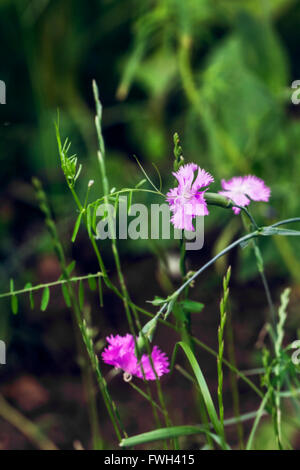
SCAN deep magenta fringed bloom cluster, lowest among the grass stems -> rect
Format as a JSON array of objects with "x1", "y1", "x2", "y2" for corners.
[{"x1": 102, "y1": 334, "x2": 170, "y2": 380}]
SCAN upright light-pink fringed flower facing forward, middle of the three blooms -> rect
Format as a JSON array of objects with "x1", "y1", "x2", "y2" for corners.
[{"x1": 167, "y1": 163, "x2": 214, "y2": 231}]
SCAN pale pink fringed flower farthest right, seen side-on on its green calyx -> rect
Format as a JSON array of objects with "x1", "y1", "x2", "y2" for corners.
[{"x1": 219, "y1": 175, "x2": 271, "y2": 214}]
